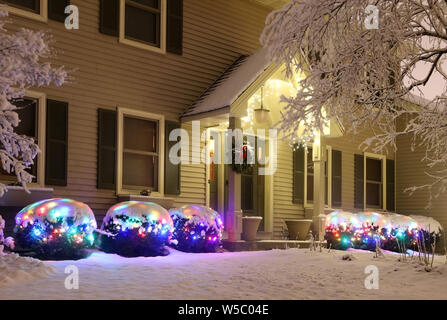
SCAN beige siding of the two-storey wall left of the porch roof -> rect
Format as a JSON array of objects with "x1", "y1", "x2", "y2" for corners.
[{"x1": 10, "y1": 0, "x2": 269, "y2": 213}]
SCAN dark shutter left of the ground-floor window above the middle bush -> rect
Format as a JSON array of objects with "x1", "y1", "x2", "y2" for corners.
[{"x1": 97, "y1": 109, "x2": 116, "y2": 190}]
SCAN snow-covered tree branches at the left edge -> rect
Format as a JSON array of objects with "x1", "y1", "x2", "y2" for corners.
[{"x1": 0, "y1": 8, "x2": 67, "y2": 196}]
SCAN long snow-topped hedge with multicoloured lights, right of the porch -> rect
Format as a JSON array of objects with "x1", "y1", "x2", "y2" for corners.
[{"x1": 325, "y1": 211, "x2": 443, "y2": 252}]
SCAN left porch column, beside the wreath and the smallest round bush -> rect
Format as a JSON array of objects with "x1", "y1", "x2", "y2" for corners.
[{"x1": 229, "y1": 116, "x2": 242, "y2": 241}]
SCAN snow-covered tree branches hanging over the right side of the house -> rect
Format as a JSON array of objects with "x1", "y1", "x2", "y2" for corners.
[{"x1": 261, "y1": 0, "x2": 447, "y2": 205}]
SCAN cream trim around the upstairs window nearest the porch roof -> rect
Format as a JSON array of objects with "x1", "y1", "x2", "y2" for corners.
[{"x1": 118, "y1": 0, "x2": 167, "y2": 54}]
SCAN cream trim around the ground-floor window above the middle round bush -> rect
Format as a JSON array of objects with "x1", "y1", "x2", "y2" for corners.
[{"x1": 116, "y1": 107, "x2": 165, "y2": 197}]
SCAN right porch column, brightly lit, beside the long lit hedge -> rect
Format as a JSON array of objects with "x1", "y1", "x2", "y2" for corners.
[{"x1": 312, "y1": 135, "x2": 326, "y2": 240}]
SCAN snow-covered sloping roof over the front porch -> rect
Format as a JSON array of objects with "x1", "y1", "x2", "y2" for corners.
[{"x1": 181, "y1": 49, "x2": 271, "y2": 118}]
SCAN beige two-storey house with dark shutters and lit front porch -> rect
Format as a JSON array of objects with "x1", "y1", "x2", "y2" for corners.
[{"x1": 0, "y1": 0, "x2": 447, "y2": 240}]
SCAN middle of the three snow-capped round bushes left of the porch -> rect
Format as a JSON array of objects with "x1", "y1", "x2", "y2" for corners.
[{"x1": 100, "y1": 201, "x2": 173, "y2": 257}]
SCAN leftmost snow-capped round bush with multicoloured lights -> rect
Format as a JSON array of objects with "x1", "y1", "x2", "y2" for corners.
[{"x1": 14, "y1": 198, "x2": 97, "y2": 260}]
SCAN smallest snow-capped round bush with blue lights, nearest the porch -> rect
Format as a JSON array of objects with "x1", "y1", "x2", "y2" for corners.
[{"x1": 169, "y1": 205, "x2": 223, "y2": 252}]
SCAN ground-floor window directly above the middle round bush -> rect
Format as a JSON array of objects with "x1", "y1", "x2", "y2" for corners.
[{"x1": 118, "y1": 109, "x2": 164, "y2": 195}]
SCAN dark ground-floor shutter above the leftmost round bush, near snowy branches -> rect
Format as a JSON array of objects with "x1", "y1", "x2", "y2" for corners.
[{"x1": 45, "y1": 100, "x2": 68, "y2": 186}]
